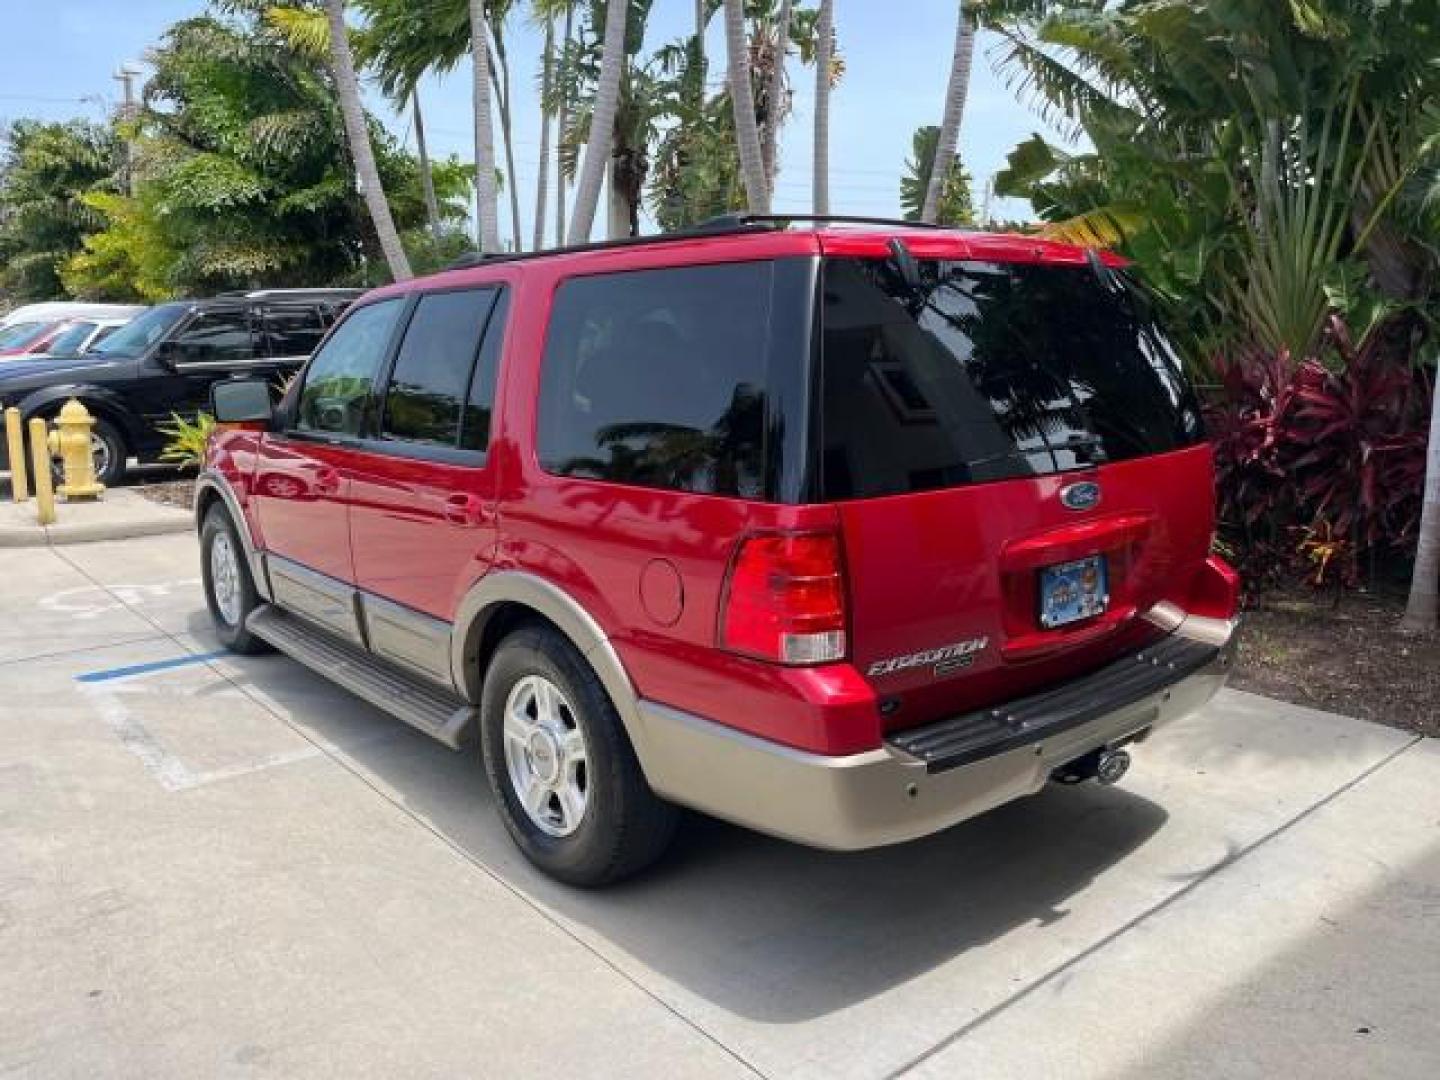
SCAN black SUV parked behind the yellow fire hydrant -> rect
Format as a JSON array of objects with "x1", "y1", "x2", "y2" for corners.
[{"x1": 0, "y1": 289, "x2": 361, "y2": 484}]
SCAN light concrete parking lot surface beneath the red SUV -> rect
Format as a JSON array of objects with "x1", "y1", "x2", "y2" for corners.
[{"x1": 0, "y1": 536, "x2": 1440, "y2": 1080}]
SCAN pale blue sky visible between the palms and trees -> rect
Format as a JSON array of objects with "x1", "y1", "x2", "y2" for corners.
[{"x1": 0, "y1": 0, "x2": 1071, "y2": 246}]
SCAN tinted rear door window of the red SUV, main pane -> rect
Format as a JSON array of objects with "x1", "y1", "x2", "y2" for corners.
[{"x1": 382, "y1": 288, "x2": 495, "y2": 449}]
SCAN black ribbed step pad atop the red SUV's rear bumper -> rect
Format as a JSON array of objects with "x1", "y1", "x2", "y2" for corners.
[{"x1": 886, "y1": 635, "x2": 1224, "y2": 773}]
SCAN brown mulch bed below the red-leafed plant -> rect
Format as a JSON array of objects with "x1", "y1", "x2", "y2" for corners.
[{"x1": 1230, "y1": 590, "x2": 1440, "y2": 736}]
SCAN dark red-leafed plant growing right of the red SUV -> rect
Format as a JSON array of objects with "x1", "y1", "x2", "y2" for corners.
[{"x1": 1210, "y1": 317, "x2": 1430, "y2": 586}]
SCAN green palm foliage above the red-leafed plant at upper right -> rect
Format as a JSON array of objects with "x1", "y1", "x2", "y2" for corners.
[{"x1": 981, "y1": 0, "x2": 1440, "y2": 360}]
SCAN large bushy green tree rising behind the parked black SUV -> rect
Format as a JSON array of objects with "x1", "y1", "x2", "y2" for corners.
[{"x1": 65, "y1": 0, "x2": 474, "y2": 300}]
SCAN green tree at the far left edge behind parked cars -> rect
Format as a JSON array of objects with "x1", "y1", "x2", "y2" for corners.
[{"x1": 0, "y1": 120, "x2": 120, "y2": 301}]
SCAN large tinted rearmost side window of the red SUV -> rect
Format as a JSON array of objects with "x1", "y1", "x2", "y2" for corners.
[{"x1": 537, "y1": 262, "x2": 775, "y2": 498}]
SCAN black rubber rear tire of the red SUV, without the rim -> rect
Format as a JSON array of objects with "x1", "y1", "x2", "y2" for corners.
[{"x1": 481, "y1": 624, "x2": 680, "y2": 887}]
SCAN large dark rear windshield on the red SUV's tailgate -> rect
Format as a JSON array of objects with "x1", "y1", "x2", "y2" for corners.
[{"x1": 821, "y1": 258, "x2": 1204, "y2": 500}]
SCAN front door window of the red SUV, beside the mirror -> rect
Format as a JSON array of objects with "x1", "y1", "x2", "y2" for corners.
[{"x1": 295, "y1": 297, "x2": 406, "y2": 435}]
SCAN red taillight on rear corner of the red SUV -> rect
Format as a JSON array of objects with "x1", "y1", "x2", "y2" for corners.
[{"x1": 720, "y1": 533, "x2": 845, "y2": 664}]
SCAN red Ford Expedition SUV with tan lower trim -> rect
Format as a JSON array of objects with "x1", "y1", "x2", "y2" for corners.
[{"x1": 196, "y1": 217, "x2": 1238, "y2": 884}]
